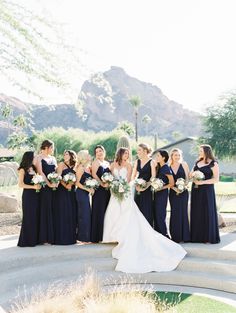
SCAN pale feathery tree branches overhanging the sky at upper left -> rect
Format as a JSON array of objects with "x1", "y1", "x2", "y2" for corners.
[{"x1": 0, "y1": 0, "x2": 84, "y2": 100}]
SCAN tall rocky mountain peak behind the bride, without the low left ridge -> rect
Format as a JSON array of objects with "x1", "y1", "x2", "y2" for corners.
[{"x1": 80, "y1": 66, "x2": 200, "y2": 138}]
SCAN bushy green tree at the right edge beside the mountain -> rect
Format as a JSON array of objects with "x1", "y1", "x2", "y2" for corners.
[{"x1": 200, "y1": 94, "x2": 236, "y2": 158}]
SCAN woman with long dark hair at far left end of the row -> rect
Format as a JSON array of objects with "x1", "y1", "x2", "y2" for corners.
[{"x1": 18, "y1": 151, "x2": 41, "y2": 247}]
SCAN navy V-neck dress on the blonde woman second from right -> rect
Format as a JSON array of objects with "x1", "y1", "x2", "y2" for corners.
[{"x1": 169, "y1": 164, "x2": 190, "y2": 242}]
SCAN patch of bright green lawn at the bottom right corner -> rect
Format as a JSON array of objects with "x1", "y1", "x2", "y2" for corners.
[{"x1": 155, "y1": 291, "x2": 236, "y2": 313}]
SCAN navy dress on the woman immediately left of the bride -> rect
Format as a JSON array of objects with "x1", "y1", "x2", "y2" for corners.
[{"x1": 91, "y1": 165, "x2": 111, "y2": 242}]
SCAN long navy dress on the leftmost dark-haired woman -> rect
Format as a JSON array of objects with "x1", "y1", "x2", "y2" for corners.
[{"x1": 18, "y1": 172, "x2": 39, "y2": 247}]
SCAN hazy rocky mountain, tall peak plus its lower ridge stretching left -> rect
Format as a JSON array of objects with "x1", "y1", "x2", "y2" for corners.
[{"x1": 0, "y1": 66, "x2": 203, "y2": 143}]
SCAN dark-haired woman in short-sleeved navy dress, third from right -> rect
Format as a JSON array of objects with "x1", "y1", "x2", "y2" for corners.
[{"x1": 154, "y1": 150, "x2": 174, "y2": 237}]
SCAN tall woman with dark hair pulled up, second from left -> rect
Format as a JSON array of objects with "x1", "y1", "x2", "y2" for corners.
[{"x1": 36, "y1": 140, "x2": 57, "y2": 244}]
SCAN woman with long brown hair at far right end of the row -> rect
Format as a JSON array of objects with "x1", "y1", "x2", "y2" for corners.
[{"x1": 190, "y1": 145, "x2": 220, "y2": 243}]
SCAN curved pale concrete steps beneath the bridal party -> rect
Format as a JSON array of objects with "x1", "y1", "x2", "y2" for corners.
[{"x1": 0, "y1": 233, "x2": 236, "y2": 313}]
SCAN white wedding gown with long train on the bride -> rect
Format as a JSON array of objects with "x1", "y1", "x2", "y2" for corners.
[{"x1": 103, "y1": 168, "x2": 186, "y2": 273}]
